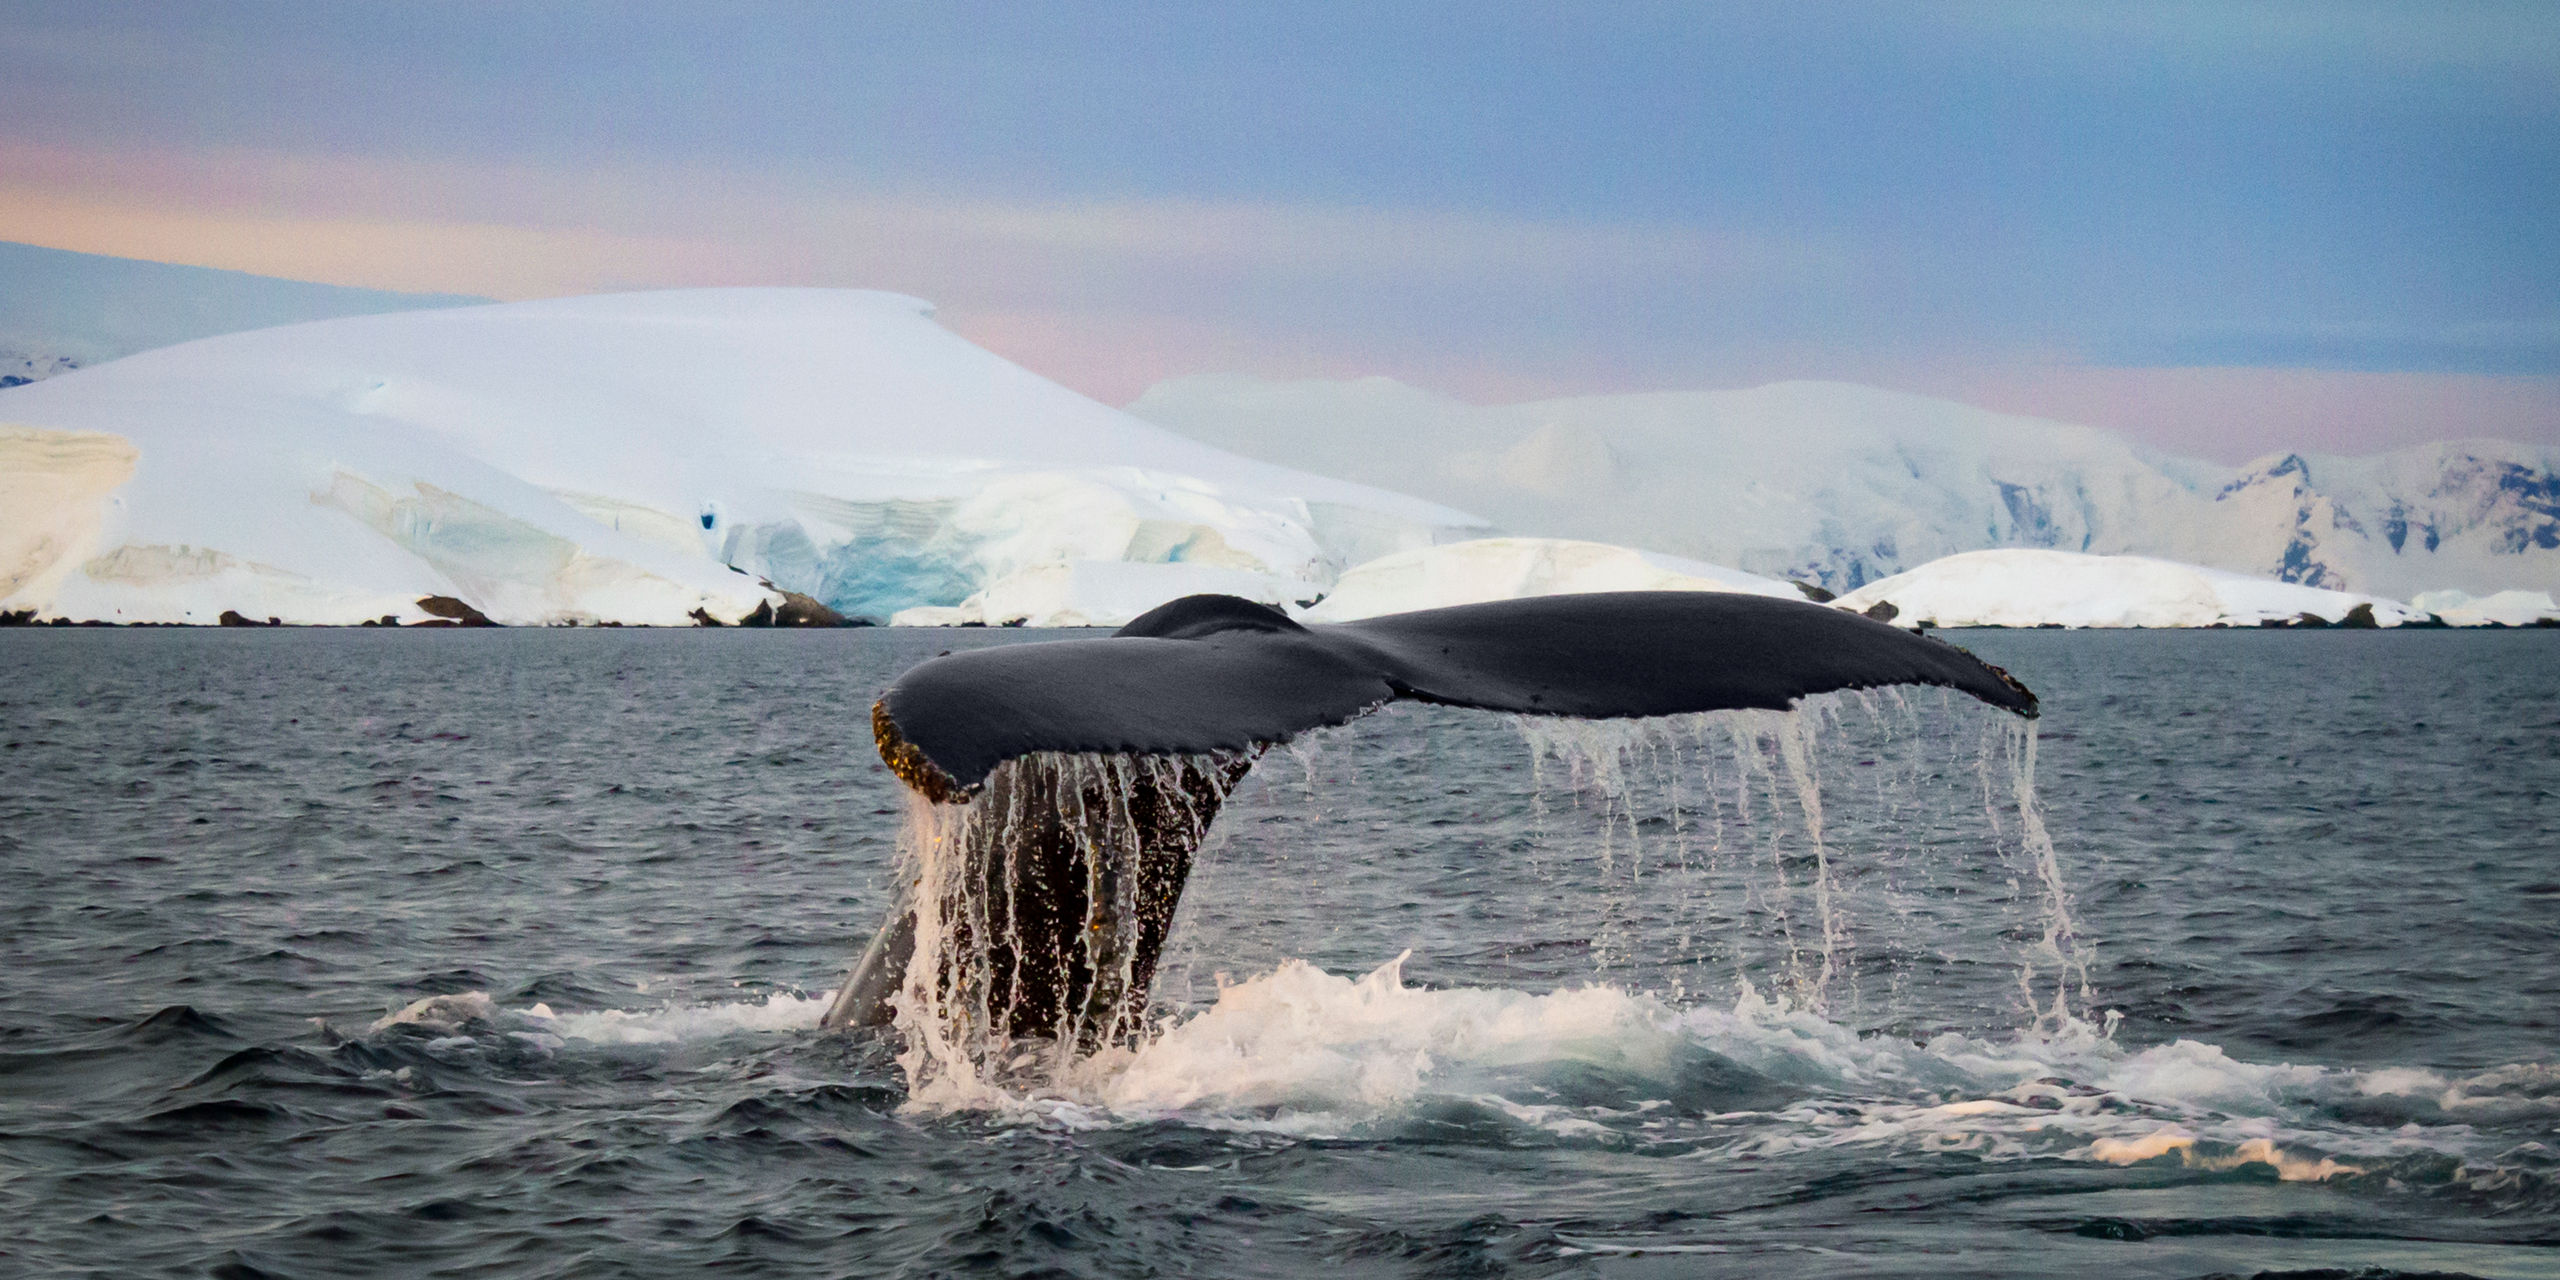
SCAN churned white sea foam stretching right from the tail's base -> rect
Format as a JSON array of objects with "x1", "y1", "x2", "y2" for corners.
[{"x1": 880, "y1": 955, "x2": 2560, "y2": 1180}]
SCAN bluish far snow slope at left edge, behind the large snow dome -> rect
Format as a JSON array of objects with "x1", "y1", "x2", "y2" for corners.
[{"x1": 0, "y1": 241, "x2": 486, "y2": 387}]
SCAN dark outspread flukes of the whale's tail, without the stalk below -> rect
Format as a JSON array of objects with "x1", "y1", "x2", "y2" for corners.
[{"x1": 870, "y1": 591, "x2": 2035, "y2": 804}]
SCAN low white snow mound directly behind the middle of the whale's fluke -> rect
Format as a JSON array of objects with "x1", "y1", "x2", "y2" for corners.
[{"x1": 1306, "y1": 538, "x2": 1805, "y2": 622}]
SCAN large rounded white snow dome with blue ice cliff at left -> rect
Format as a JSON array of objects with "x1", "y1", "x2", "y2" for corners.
[{"x1": 0, "y1": 289, "x2": 1482, "y2": 625}]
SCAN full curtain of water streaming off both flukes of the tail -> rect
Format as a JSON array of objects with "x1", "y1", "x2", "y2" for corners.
[{"x1": 899, "y1": 691, "x2": 2089, "y2": 1106}]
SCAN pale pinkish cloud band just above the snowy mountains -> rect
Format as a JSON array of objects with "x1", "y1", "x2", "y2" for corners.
[{"x1": 0, "y1": 141, "x2": 2560, "y2": 461}]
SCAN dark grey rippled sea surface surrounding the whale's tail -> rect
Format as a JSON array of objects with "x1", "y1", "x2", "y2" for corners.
[{"x1": 0, "y1": 630, "x2": 2560, "y2": 1277}]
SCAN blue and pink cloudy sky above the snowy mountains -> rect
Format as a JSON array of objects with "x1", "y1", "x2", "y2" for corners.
[{"x1": 0, "y1": 0, "x2": 2560, "y2": 461}]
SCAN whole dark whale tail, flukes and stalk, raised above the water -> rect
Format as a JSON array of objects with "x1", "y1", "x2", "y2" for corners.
[{"x1": 827, "y1": 591, "x2": 2035, "y2": 1047}]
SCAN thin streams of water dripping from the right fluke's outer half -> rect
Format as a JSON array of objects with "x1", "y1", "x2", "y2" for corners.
[{"x1": 1516, "y1": 689, "x2": 2092, "y2": 1037}]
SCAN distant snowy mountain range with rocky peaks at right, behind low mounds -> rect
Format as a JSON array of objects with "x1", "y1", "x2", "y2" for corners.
[{"x1": 1129, "y1": 376, "x2": 2560, "y2": 599}]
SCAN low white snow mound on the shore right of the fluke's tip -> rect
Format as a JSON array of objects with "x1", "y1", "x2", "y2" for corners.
[{"x1": 1838, "y1": 548, "x2": 2424, "y2": 627}]
